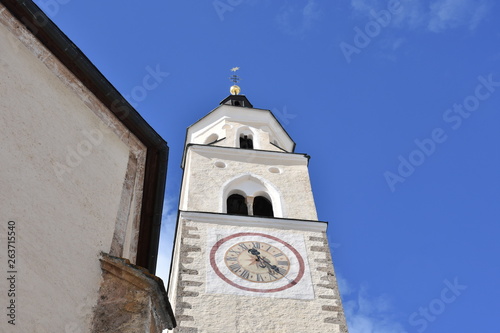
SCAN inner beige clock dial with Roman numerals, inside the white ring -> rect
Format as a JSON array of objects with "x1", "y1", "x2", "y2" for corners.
[{"x1": 224, "y1": 241, "x2": 290, "y2": 283}]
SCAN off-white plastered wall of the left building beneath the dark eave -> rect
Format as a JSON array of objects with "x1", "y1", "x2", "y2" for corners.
[{"x1": 0, "y1": 5, "x2": 158, "y2": 333}]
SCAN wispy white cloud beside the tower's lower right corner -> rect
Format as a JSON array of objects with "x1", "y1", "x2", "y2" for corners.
[{"x1": 337, "y1": 276, "x2": 406, "y2": 333}]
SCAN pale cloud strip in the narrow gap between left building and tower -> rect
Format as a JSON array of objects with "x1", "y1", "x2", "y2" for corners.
[{"x1": 156, "y1": 197, "x2": 181, "y2": 286}]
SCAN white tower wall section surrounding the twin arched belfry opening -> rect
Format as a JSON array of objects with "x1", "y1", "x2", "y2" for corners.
[{"x1": 179, "y1": 146, "x2": 317, "y2": 220}]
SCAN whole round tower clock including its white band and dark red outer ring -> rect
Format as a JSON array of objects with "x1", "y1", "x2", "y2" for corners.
[{"x1": 210, "y1": 232, "x2": 305, "y2": 293}]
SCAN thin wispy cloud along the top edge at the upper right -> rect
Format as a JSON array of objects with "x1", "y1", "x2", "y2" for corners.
[{"x1": 351, "y1": 0, "x2": 493, "y2": 32}]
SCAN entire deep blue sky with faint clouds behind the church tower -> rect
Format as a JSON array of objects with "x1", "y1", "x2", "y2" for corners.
[{"x1": 36, "y1": 0, "x2": 500, "y2": 333}]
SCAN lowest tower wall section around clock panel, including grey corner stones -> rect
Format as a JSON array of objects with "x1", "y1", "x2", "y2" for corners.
[{"x1": 170, "y1": 215, "x2": 347, "y2": 333}]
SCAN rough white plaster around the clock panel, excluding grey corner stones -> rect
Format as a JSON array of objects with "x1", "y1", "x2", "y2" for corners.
[{"x1": 169, "y1": 212, "x2": 342, "y2": 333}]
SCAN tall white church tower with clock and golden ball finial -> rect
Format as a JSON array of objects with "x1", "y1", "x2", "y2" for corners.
[{"x1": 168, "y1": 68, "x2": 347, "y2": 333}]
